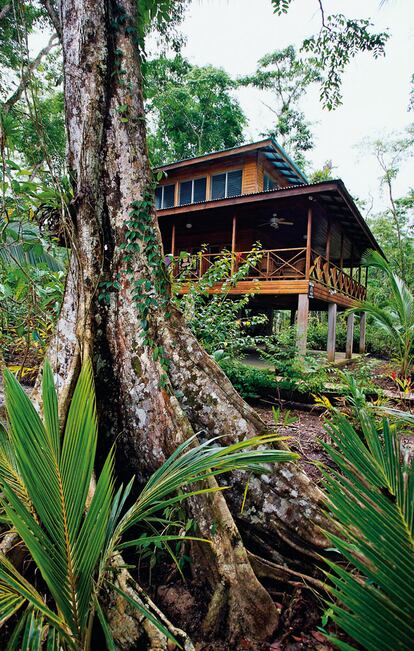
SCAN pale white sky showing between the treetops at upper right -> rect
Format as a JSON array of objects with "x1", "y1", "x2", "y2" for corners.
[{"x1": 181, "y1": 0, "x2": 414, "y2": 211}]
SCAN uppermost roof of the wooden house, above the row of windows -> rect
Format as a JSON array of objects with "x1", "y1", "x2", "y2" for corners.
[{"x1": 155, "y1": 138, "x2": 308, "y2": 185}]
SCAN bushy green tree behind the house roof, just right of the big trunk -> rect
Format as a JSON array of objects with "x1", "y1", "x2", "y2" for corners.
[{"x1": 144, "y1": 55, "x2": 246, "y2": 165}]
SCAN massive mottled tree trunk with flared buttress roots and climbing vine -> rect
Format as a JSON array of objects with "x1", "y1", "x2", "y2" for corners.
[{"x1": 44, "y1": 0, "x2": 325, "y2": 649}]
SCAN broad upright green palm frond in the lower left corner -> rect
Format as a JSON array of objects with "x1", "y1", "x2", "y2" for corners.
[{"x1": 1, "y1": 363, "x2": 113, "y2": 640}]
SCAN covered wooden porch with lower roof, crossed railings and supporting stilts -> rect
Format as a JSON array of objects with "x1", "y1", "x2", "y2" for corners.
[{"x1": 158, "y1": 181, "x2": 378, "y2": 361}]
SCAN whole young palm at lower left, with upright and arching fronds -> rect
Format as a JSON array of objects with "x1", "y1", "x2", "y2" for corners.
[{"x1": 0, "y1": 362, "x2": 297, "y2": 650}]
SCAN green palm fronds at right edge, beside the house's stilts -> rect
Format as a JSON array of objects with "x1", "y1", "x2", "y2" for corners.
[{"x1": 350, "y1": 251, "x2": 414, "y2": 378}]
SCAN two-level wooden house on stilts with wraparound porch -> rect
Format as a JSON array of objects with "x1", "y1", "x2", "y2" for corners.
[{"x1": 156, "y1": 139, "x2": 380, "y2": 361}]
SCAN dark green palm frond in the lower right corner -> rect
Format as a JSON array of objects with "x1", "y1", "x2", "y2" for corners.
[{"x1": 323, "y1": 384, "x2": 414, "y2": 651}]
